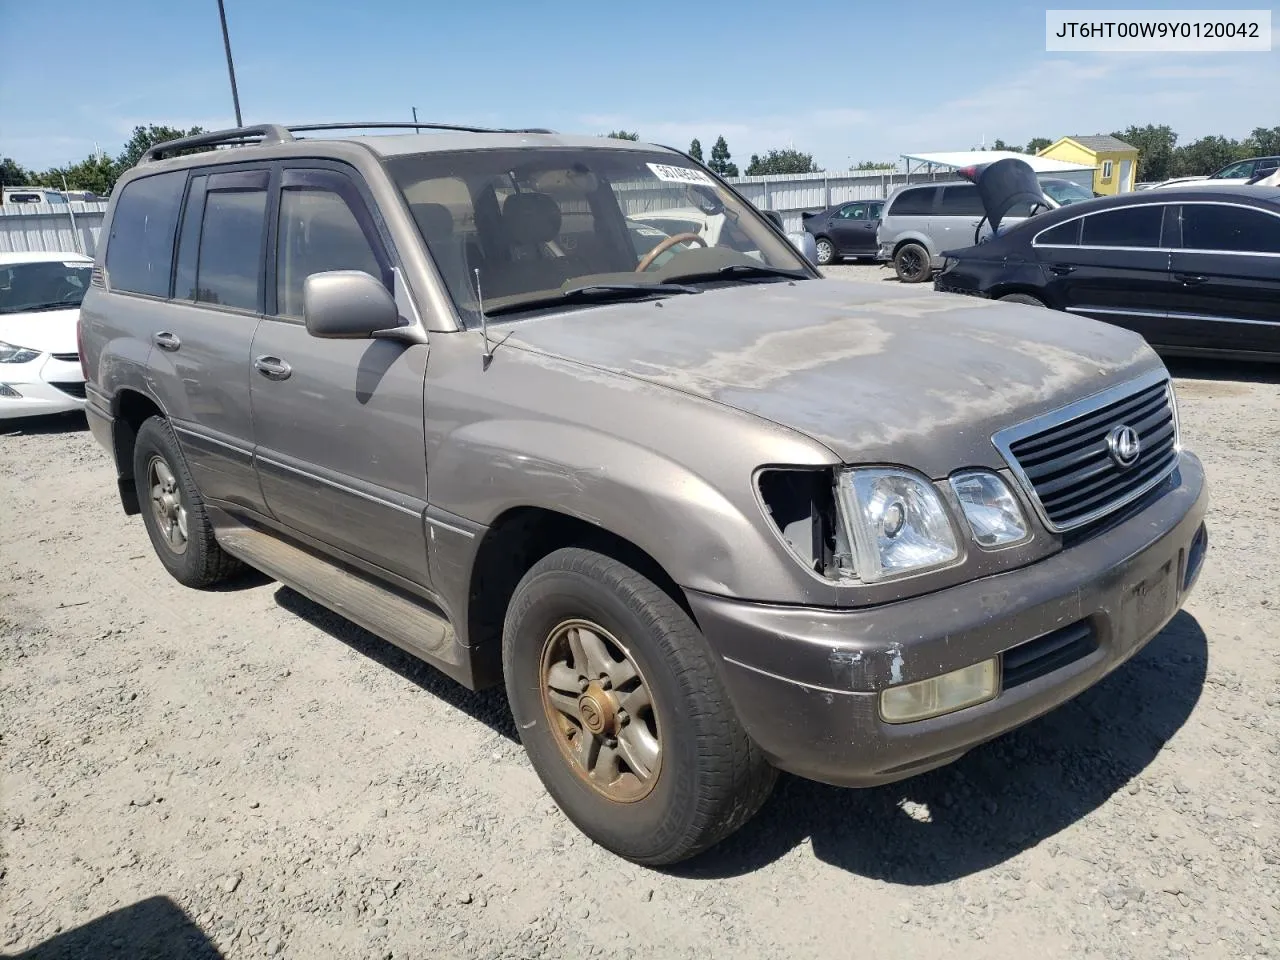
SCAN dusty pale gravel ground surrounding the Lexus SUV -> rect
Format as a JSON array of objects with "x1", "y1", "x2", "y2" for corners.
[{"x1": 0, "y1": 280, "x2": 1280, "y2": 960}]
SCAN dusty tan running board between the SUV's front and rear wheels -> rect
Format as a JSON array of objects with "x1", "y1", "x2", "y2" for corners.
[{"x1": 210, "y1": 511, "x2": 474, "y2": 686}]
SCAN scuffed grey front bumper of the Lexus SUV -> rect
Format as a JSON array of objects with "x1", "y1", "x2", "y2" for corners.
[{"x1": 687, "y1": 453, "x2": 1208, "y2": 786}]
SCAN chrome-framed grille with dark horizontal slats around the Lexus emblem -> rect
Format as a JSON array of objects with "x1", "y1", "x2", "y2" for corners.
[{"x1": 992, "y1": 370, "x2": 1179, "y2": 532}]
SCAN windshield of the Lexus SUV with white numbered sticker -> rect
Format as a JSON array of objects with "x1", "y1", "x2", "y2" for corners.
[{"x1": 387, "y1": 148, "x2": 812, "y2": 320}]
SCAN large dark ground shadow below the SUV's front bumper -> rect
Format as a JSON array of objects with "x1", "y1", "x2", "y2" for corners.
[{"x1": 672, "y1": 612, "x2": 1208, "y2": 886}]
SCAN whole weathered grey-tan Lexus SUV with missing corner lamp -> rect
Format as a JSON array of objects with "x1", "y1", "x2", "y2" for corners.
[{"x1": 81, "y1": 124, "x2": 1207, "y2": 864}]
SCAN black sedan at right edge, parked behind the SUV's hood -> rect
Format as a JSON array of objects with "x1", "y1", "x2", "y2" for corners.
[{"x1": 934, "y1": 186, "x2": 1280, "y2": 360}]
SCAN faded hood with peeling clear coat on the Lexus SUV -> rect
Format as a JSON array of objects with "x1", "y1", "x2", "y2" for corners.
[{"x1": 501, "y1": 280, "x2": 1160, "y2": 477}]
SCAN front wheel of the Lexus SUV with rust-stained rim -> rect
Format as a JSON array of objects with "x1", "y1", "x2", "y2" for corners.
[{"x1": 502, "y1": 548, "x2": 777, "y2": 867}]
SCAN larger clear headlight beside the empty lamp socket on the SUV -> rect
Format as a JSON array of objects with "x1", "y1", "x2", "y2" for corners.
[{"x1": 837, "y1": 467, "x2": 960, "y2": 582}]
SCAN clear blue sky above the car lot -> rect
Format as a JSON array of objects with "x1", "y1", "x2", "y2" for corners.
[{"x1": 0, "y1": 0, "x2": 1280, "y2": 169}]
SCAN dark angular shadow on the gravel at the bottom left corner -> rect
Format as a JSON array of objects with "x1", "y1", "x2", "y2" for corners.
[{"x1": 3, "y1": 897, "x2": 223, "y2": 960}]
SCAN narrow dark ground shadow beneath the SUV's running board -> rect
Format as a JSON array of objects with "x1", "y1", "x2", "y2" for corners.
[{"x1": 275, "y1": 585, "x2": 520, "y2": 744}]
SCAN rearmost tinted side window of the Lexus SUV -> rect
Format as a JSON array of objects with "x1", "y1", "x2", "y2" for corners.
[{"x1": 106, "y1": 170, "x2": 187, "y2": 297}]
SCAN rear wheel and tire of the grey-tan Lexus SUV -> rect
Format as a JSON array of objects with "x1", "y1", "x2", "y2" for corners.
[{"x1": 133, "y1": 416, "x2": 243, "y2": 588}]
